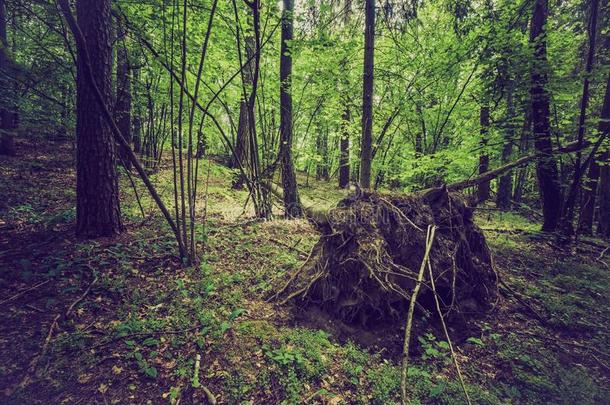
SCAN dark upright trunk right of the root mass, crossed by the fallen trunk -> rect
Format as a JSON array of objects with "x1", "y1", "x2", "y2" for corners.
[{"x1": 530, "y1": 0, "x2": 562, "y2": 232}]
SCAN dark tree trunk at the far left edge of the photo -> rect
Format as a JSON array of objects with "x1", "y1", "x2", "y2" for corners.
[{"x1": 0, "y1": 0, "x2": 16, "y2": 156}]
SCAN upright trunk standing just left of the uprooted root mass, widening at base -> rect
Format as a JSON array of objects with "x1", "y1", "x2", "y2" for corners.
[{"x1": 280, "y1": 0, "x2": 303, "y2": 217}]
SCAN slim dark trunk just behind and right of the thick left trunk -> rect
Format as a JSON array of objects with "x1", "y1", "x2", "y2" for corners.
[{"x1": 114, "y1": 18, "x2": 132, "y2": 170}]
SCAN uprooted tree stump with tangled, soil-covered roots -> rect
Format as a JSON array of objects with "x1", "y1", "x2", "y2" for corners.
[{"x1": 276, "y1": 187, "x2": 498, "y2": 326}]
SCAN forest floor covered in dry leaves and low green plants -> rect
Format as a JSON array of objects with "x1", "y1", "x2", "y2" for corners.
[{"x1": 0, "y1": 141, "x2": 610, "y2": 404}]
